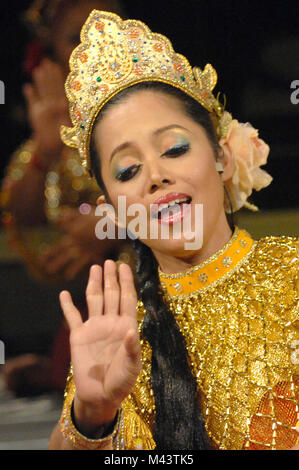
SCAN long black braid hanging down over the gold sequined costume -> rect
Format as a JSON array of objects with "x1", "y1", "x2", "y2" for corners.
[{"x1": 134, "y1": 240, "x2": 206, "y2": 450}]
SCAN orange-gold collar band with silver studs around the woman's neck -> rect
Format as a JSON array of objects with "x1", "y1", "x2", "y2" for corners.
[{"x1": 159, "y1": 227, "x2": 256, "y2": 297}]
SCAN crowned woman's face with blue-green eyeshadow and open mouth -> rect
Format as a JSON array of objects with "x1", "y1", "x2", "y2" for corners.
[{"x1": 94, "y1": 90, "x2": 232, "y2": 258}]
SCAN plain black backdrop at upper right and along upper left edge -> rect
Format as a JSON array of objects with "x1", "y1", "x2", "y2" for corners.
[{"x1": 0, "y1": 0, "x2": 299, "y2": 209}]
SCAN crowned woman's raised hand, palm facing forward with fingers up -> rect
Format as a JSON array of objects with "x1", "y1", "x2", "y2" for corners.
[{"x1": 60, "y1": 260, "x2": 141, "y2": 429}]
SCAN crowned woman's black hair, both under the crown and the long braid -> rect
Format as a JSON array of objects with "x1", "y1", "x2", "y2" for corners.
[{"x1": 90, "y1": 82, "x2": 232, "y2": 450}]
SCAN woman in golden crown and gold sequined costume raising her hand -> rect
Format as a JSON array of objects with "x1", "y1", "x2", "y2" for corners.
[{"x1": 50, "y1": 11, "x2": 298, "y2": 450}]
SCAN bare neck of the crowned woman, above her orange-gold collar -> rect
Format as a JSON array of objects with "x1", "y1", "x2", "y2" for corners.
[{"x1": 153, "y1": 219, "x2": 232, "y2": 274}]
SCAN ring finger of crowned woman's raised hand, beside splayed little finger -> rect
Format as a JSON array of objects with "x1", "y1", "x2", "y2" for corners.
[{"x1": 86, "y1": 265, "x2": 104, "y2": 317}]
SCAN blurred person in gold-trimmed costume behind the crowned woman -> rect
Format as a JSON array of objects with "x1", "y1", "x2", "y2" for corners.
[{"x1": 0, "y1": 0, "x2": 127, "y2": 395}]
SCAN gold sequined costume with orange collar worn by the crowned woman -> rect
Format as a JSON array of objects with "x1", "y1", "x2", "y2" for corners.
[{"x1": 61, "y1": 228, "x2": 299, "y2": 450}]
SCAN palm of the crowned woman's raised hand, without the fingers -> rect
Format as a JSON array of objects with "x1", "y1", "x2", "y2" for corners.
[{"x1": 71, "y1": 315, "x2": 139, "y2": 403}]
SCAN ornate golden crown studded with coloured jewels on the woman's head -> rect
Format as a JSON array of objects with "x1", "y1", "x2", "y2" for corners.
[{"x1": 61, "y1": 10, "x2": 223, "y2": 170}]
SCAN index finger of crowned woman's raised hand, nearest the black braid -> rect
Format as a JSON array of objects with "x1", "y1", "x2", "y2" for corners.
[{"x1": 119, "y1": 263, "x2": 137, "y2": 318}]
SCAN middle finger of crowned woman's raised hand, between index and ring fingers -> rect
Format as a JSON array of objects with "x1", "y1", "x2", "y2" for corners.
[{"x1": 104, "y1": 259, "x2": 120, "y2": 315}]
